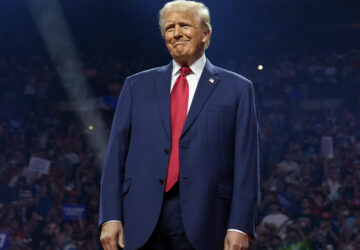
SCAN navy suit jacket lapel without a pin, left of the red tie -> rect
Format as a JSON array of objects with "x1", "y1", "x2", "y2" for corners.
[{"x1": 155, "y1": 63, "x2": 172, "y2": 142}]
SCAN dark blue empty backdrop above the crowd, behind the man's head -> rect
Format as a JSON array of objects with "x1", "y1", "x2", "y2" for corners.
[{"x1": 0, "y1": 0, "x2": 360, "y2": 58}]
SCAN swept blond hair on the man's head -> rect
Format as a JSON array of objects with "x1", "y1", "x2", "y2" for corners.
[{"x1": 159, "y1": 0, "x2": 212, "y2": 49}]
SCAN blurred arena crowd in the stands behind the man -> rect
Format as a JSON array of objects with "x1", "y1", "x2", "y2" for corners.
[{"x1": 0, "y1": 47, "x2": 360, "y2": 250}]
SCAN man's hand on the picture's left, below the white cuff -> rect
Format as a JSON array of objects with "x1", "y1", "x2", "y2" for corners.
[{"x1": 100, "y1": 221, "x2": 125, "y2": 250}]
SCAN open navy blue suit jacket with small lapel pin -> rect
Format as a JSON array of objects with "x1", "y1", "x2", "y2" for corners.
[{"x1": 99, "y1": 60, "x2": 259, "y2": 250}]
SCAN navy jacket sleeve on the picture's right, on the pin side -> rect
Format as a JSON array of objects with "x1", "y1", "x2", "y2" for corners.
[{"x1": 227, "y1": 82, "x2": 260, "y2": 238}]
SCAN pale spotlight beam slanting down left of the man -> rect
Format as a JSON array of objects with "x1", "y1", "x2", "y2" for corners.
[{"x1": 25, "y1": 0, "x2": 107, "y2": 167}]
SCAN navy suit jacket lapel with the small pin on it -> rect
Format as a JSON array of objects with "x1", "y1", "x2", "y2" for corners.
[{"x1": 180, "y1": 59, "x2": 220, "y2": 138}]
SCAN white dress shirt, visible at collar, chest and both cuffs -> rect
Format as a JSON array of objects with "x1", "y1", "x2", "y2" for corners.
[{"x1": 103, "y1": 54, "x2": 247, "y2": 238}]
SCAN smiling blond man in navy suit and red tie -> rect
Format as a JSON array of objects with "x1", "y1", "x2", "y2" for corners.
[{"x1": 99, "y1": 0, "x2": 259, "y2": 250}]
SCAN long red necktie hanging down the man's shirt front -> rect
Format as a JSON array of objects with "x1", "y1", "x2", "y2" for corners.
[{"x1": 165, "y1": 67, "x2": 191, "y2": 192}]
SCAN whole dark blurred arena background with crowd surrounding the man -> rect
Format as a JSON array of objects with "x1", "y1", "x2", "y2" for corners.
[{"x1": 0, "y1": 0, "x2": 360, "y2": 250}]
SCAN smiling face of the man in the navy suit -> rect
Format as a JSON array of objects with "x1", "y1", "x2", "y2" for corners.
[{"x1": 164, "y1": 11, "x2": 210, "y2": 66}]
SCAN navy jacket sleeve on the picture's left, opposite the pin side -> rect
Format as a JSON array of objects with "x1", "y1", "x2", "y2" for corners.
[{"x1": 99, "y1": 79, "x2": 131, "y2": 226}]
